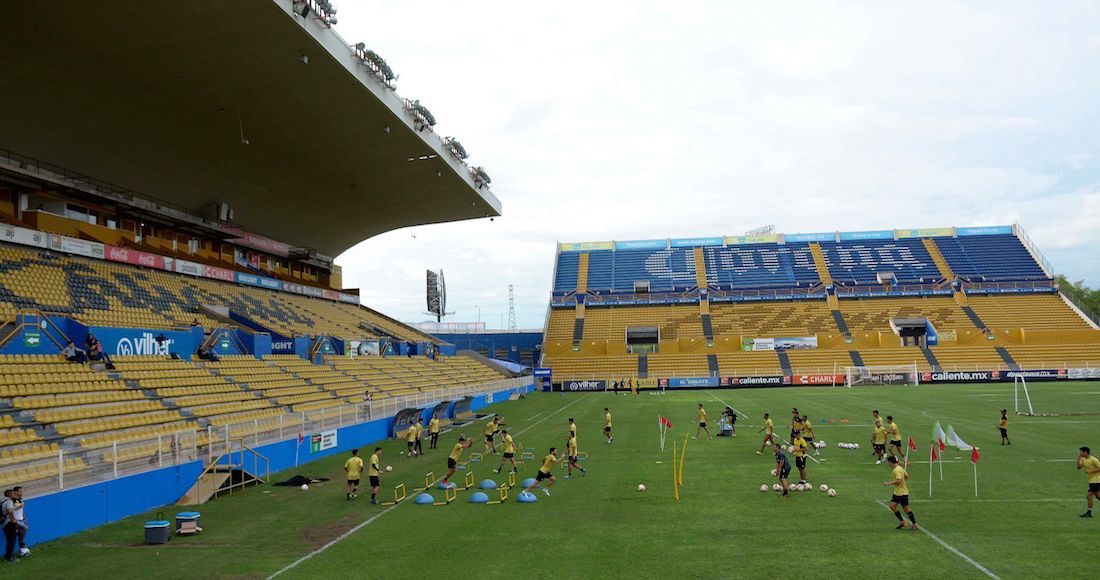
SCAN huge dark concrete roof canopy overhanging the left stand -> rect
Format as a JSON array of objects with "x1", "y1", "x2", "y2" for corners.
[{"x1": 0, "y1": 0, "x2": 501, "y2": 255}]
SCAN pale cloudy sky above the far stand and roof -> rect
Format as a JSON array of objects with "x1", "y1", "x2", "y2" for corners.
[{"x1": 334, "y1": 0, "x2": 1100, "y2": 328}]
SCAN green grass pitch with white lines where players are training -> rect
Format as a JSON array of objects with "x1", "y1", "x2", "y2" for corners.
[{"x1": 12, "y1": 383, "x2": 1100, "y2": 579}]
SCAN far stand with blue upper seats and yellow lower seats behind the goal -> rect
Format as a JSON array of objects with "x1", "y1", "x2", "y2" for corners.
[{"x1": 542, "y1": 226, "x2": 1100, "y2": 380}]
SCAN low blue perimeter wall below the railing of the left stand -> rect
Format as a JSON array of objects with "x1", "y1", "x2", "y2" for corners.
[{"x1": 26, "y1": 386, "x2": 534, "y2": 544}]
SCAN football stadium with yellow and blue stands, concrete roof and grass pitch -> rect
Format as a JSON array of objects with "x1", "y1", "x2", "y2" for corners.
[{"x1": 0, "y1": 0, "x2": 1100, "y2": 579}]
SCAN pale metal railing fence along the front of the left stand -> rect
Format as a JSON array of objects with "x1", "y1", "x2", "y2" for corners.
[{"x1": 0, "y1": 376, "x2": 532, "y2": 496}]
